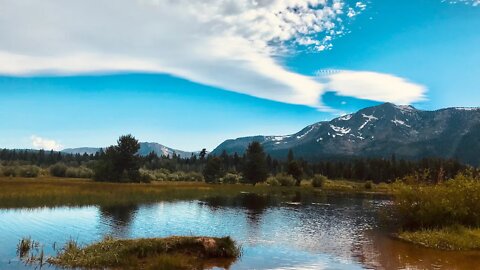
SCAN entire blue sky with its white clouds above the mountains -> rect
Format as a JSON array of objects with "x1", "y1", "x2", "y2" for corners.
[{"x1": 0, "y1": 0, "x2": 480, "y2": 150}]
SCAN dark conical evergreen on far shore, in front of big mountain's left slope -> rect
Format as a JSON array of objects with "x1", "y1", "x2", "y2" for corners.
[{"x1": 243, "y1": 142, "x2": 268, "y2": 185}]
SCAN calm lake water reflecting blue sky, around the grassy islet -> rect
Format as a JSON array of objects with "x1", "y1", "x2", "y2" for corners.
[{"x1": 0, "y1": 194, "x2": 480, "y2": 269}]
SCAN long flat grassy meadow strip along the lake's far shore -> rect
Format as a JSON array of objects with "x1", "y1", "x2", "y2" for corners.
[{"x1": 0, "y1": 177, "x2": 390, "y2": 208}]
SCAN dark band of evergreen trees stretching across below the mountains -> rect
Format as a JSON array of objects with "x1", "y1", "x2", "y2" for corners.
[{"x1": 0, "y1": 135, "x2": 469, "y2": 185}]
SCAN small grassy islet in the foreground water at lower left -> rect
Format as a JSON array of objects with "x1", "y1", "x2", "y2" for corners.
[{"x1": 47, "y1": 236, "x2": 240, "y2": 269}]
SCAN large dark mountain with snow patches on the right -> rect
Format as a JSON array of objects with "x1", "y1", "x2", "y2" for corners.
[{"x1": 212, "y1": 103, "x2": 480, "y2": 166}]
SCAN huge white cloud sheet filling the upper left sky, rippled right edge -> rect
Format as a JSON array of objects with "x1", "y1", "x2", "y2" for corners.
[{"x1": 0, "y1": 0, "x2": 365, "y2": 106}]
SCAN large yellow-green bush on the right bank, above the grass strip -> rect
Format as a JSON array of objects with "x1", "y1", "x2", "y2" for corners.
[{"x1": 393, "y1": 174, "x2": 480, "y2": 229}]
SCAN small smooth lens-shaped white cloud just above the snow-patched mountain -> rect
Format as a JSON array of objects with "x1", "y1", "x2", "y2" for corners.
[{"x1": 317, "y1": 70, "x2": 427, "y2": 104}]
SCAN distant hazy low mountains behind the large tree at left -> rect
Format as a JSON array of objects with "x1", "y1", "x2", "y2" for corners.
[{"x1": 61, "y1": 142, "x2": 197, "y2": 158}]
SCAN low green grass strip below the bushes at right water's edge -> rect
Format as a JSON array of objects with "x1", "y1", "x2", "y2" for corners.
[{"x1": 398, "y1": 226, "x2": 480, "y2": 250}]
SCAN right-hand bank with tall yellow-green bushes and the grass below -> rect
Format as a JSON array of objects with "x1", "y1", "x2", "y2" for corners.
[{"x1": 389, "y1": 174, "x2": 480, "y2": 250}]
